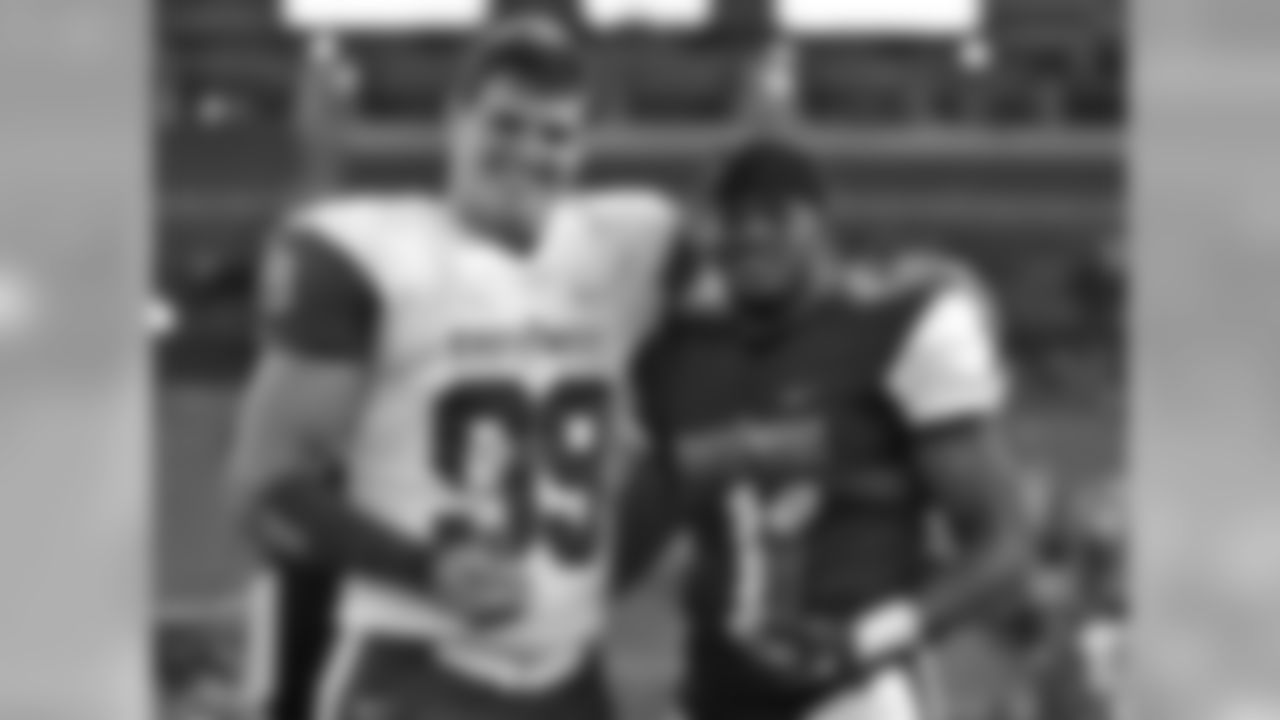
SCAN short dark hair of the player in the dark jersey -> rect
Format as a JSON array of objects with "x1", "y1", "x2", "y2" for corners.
[{"x1": 709, "y1": 137, "x2": 826, "y2": 213}]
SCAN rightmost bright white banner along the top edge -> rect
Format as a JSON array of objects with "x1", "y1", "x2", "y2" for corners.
[{"x1": 774, "y1": 0, "x2": 986, "y2": 35}]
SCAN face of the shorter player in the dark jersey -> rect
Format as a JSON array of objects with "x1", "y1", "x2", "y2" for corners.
[{"x1": 714, "y1": 202, "x2": 824, "y2": 302}]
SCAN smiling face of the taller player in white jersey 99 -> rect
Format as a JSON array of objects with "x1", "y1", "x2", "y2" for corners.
[{"x1": 448, "y1": 77, "x2": 588, "y2": 235}]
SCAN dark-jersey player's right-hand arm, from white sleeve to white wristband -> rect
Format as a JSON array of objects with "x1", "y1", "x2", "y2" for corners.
[{"x1": 852, "y1": 287, "x2": 1034, "y2": 656}]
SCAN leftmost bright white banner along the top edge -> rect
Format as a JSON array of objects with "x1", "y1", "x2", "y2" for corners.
[{"x1": 282, "y1": 0, "x2": 490, "y2": 31}]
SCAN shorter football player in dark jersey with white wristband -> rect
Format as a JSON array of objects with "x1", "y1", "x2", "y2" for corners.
[{"x1": 620, "y1": 140, "x2": 1033, "y2": 720}]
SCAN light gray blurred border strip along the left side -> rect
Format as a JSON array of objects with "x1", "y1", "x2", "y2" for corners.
[{"x1": 0, "y1": 0, "x2": 150, "y2": 720}]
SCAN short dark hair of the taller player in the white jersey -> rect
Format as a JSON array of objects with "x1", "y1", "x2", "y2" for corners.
[{"x1": 453, "y1": 15, "x2": 589, "y2": 100}]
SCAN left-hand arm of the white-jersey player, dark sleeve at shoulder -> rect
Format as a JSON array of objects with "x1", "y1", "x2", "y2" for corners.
[{"x1": 230, "y1": 221, "x2": 512, "y2": 620}]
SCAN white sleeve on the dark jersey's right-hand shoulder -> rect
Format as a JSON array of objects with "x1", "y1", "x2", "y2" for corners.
[{"x1": 887, "y1": 288, "x2": 1009, "y2": 425}]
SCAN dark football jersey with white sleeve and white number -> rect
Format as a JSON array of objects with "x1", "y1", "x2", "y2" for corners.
[{"x1": 639, "y1": 262, "x2": 1005, "y2": 634}]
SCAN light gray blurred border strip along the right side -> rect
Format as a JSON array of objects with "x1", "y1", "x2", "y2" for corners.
[{"x1": 1132, "y1": 0, "x2": 1280, "y2": 720}]
